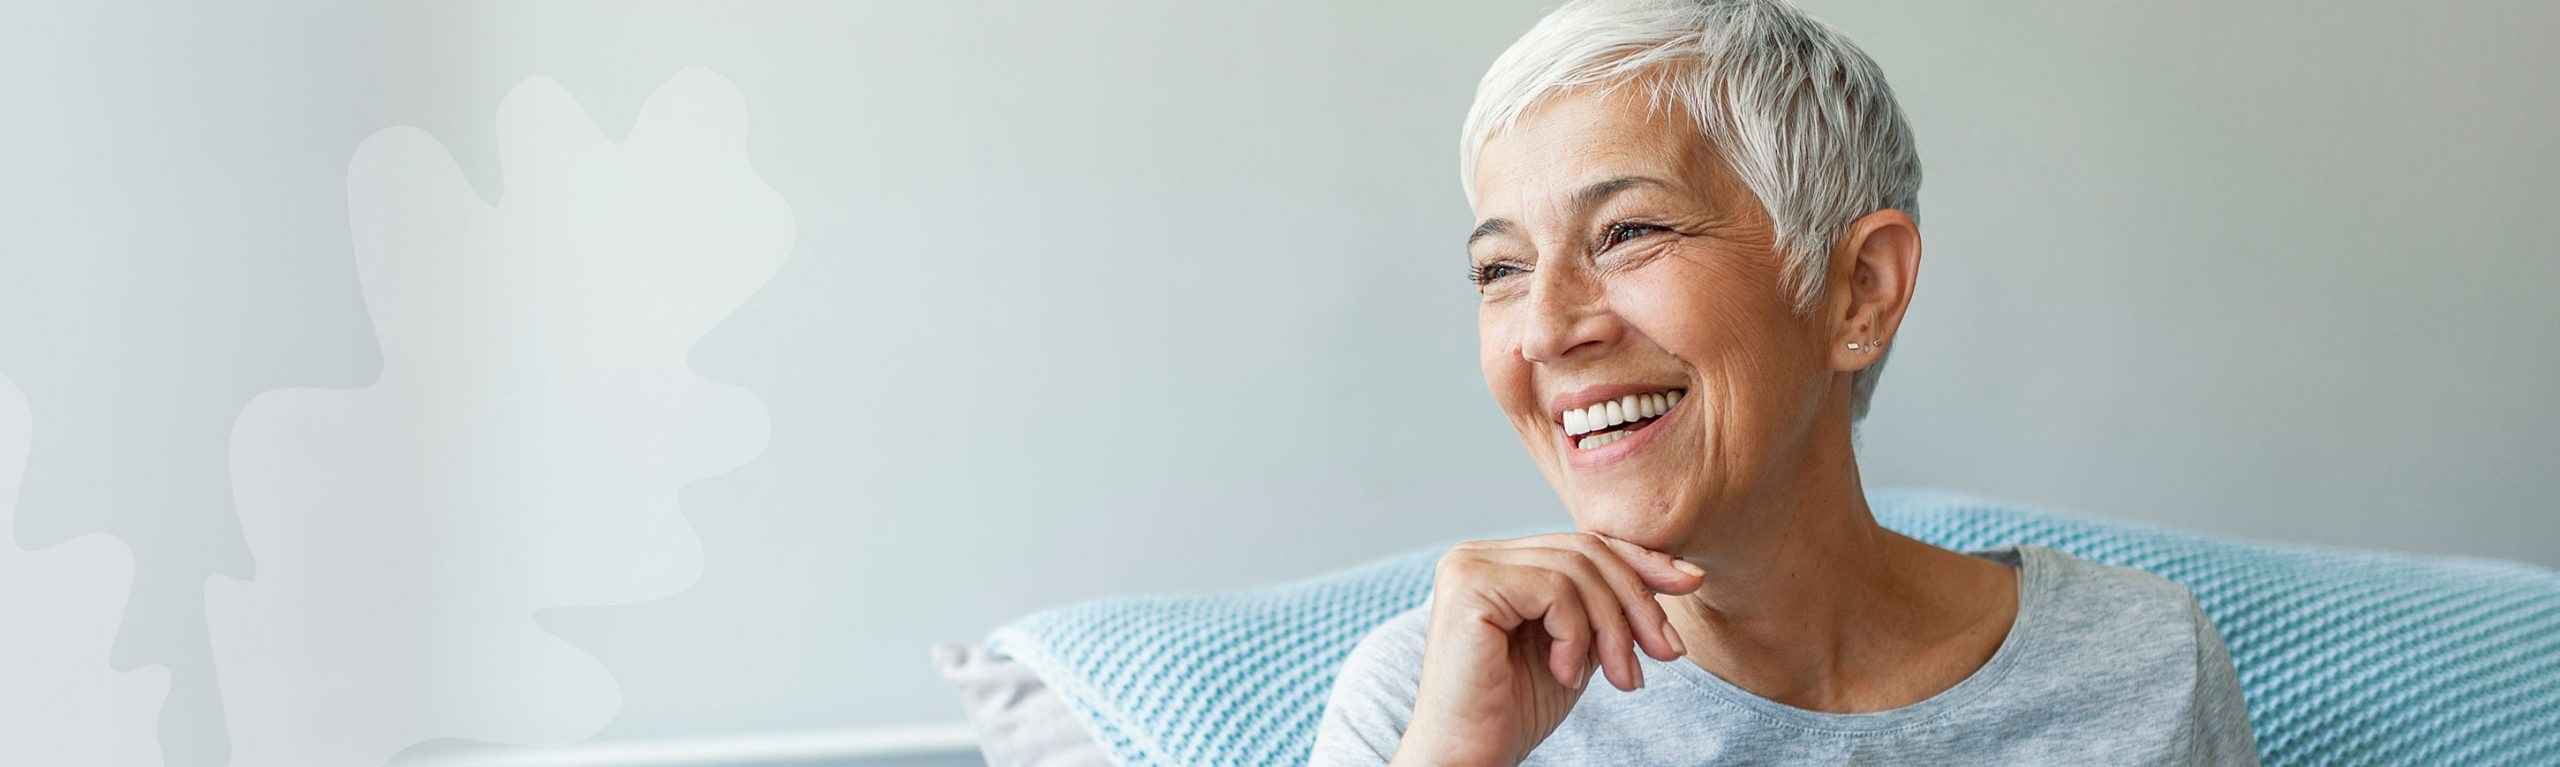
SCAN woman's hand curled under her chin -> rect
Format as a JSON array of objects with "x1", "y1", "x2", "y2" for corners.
[{"x1": 1395, "y1": 532, "x2": 1705, "y2": 767}]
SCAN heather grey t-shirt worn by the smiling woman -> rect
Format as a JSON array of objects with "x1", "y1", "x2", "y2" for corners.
[{"x1": 1313, "y1": 545, "x2": 2258, "y2": 764}]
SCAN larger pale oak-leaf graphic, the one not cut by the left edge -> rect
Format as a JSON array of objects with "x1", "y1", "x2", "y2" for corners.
[{"x1": 205, "y1": 69, "x2": 794, "y2": 767}]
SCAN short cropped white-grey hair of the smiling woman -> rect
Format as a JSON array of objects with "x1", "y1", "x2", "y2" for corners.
[{"x1": 1459, "y1": 0, "x2": 1920, "y2": 422}]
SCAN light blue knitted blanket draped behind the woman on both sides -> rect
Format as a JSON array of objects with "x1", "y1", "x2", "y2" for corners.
[{"x1": 988, "y1": 488, "x2": 2560, "y2": 767}]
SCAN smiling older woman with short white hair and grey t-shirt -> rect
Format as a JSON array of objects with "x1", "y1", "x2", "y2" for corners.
[{"x1": 1316, "y1": 0, "x2": 2258, "y2": 764}]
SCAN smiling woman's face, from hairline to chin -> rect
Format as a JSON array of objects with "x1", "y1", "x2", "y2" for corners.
[{"x1": 1467, "y1": 87, "x2": 1848, "y2": 552}]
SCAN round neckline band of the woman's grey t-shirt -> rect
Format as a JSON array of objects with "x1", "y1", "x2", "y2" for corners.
[{"x1": 1646, "y1": 545, "x2": 2053, "y2": 734}]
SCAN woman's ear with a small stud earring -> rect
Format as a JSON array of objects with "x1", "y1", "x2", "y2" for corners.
[{"x1": 1823, "y1": 207, "x2": 1920, "y2": 373}]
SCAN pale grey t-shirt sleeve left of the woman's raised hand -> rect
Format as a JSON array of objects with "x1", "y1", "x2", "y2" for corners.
[{"x1": 1308, "y1": 608, "x2": 1428, "y2": 767}]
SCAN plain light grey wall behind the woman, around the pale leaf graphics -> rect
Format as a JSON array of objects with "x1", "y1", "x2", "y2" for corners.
[{"x1": 0, "y1": 0, "x2": 2560, "y2": 764}]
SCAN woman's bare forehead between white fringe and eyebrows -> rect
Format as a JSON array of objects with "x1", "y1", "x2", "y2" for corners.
[{"x1": 1475, "y1": 87, "x2": 1715, "y2": 217}]
